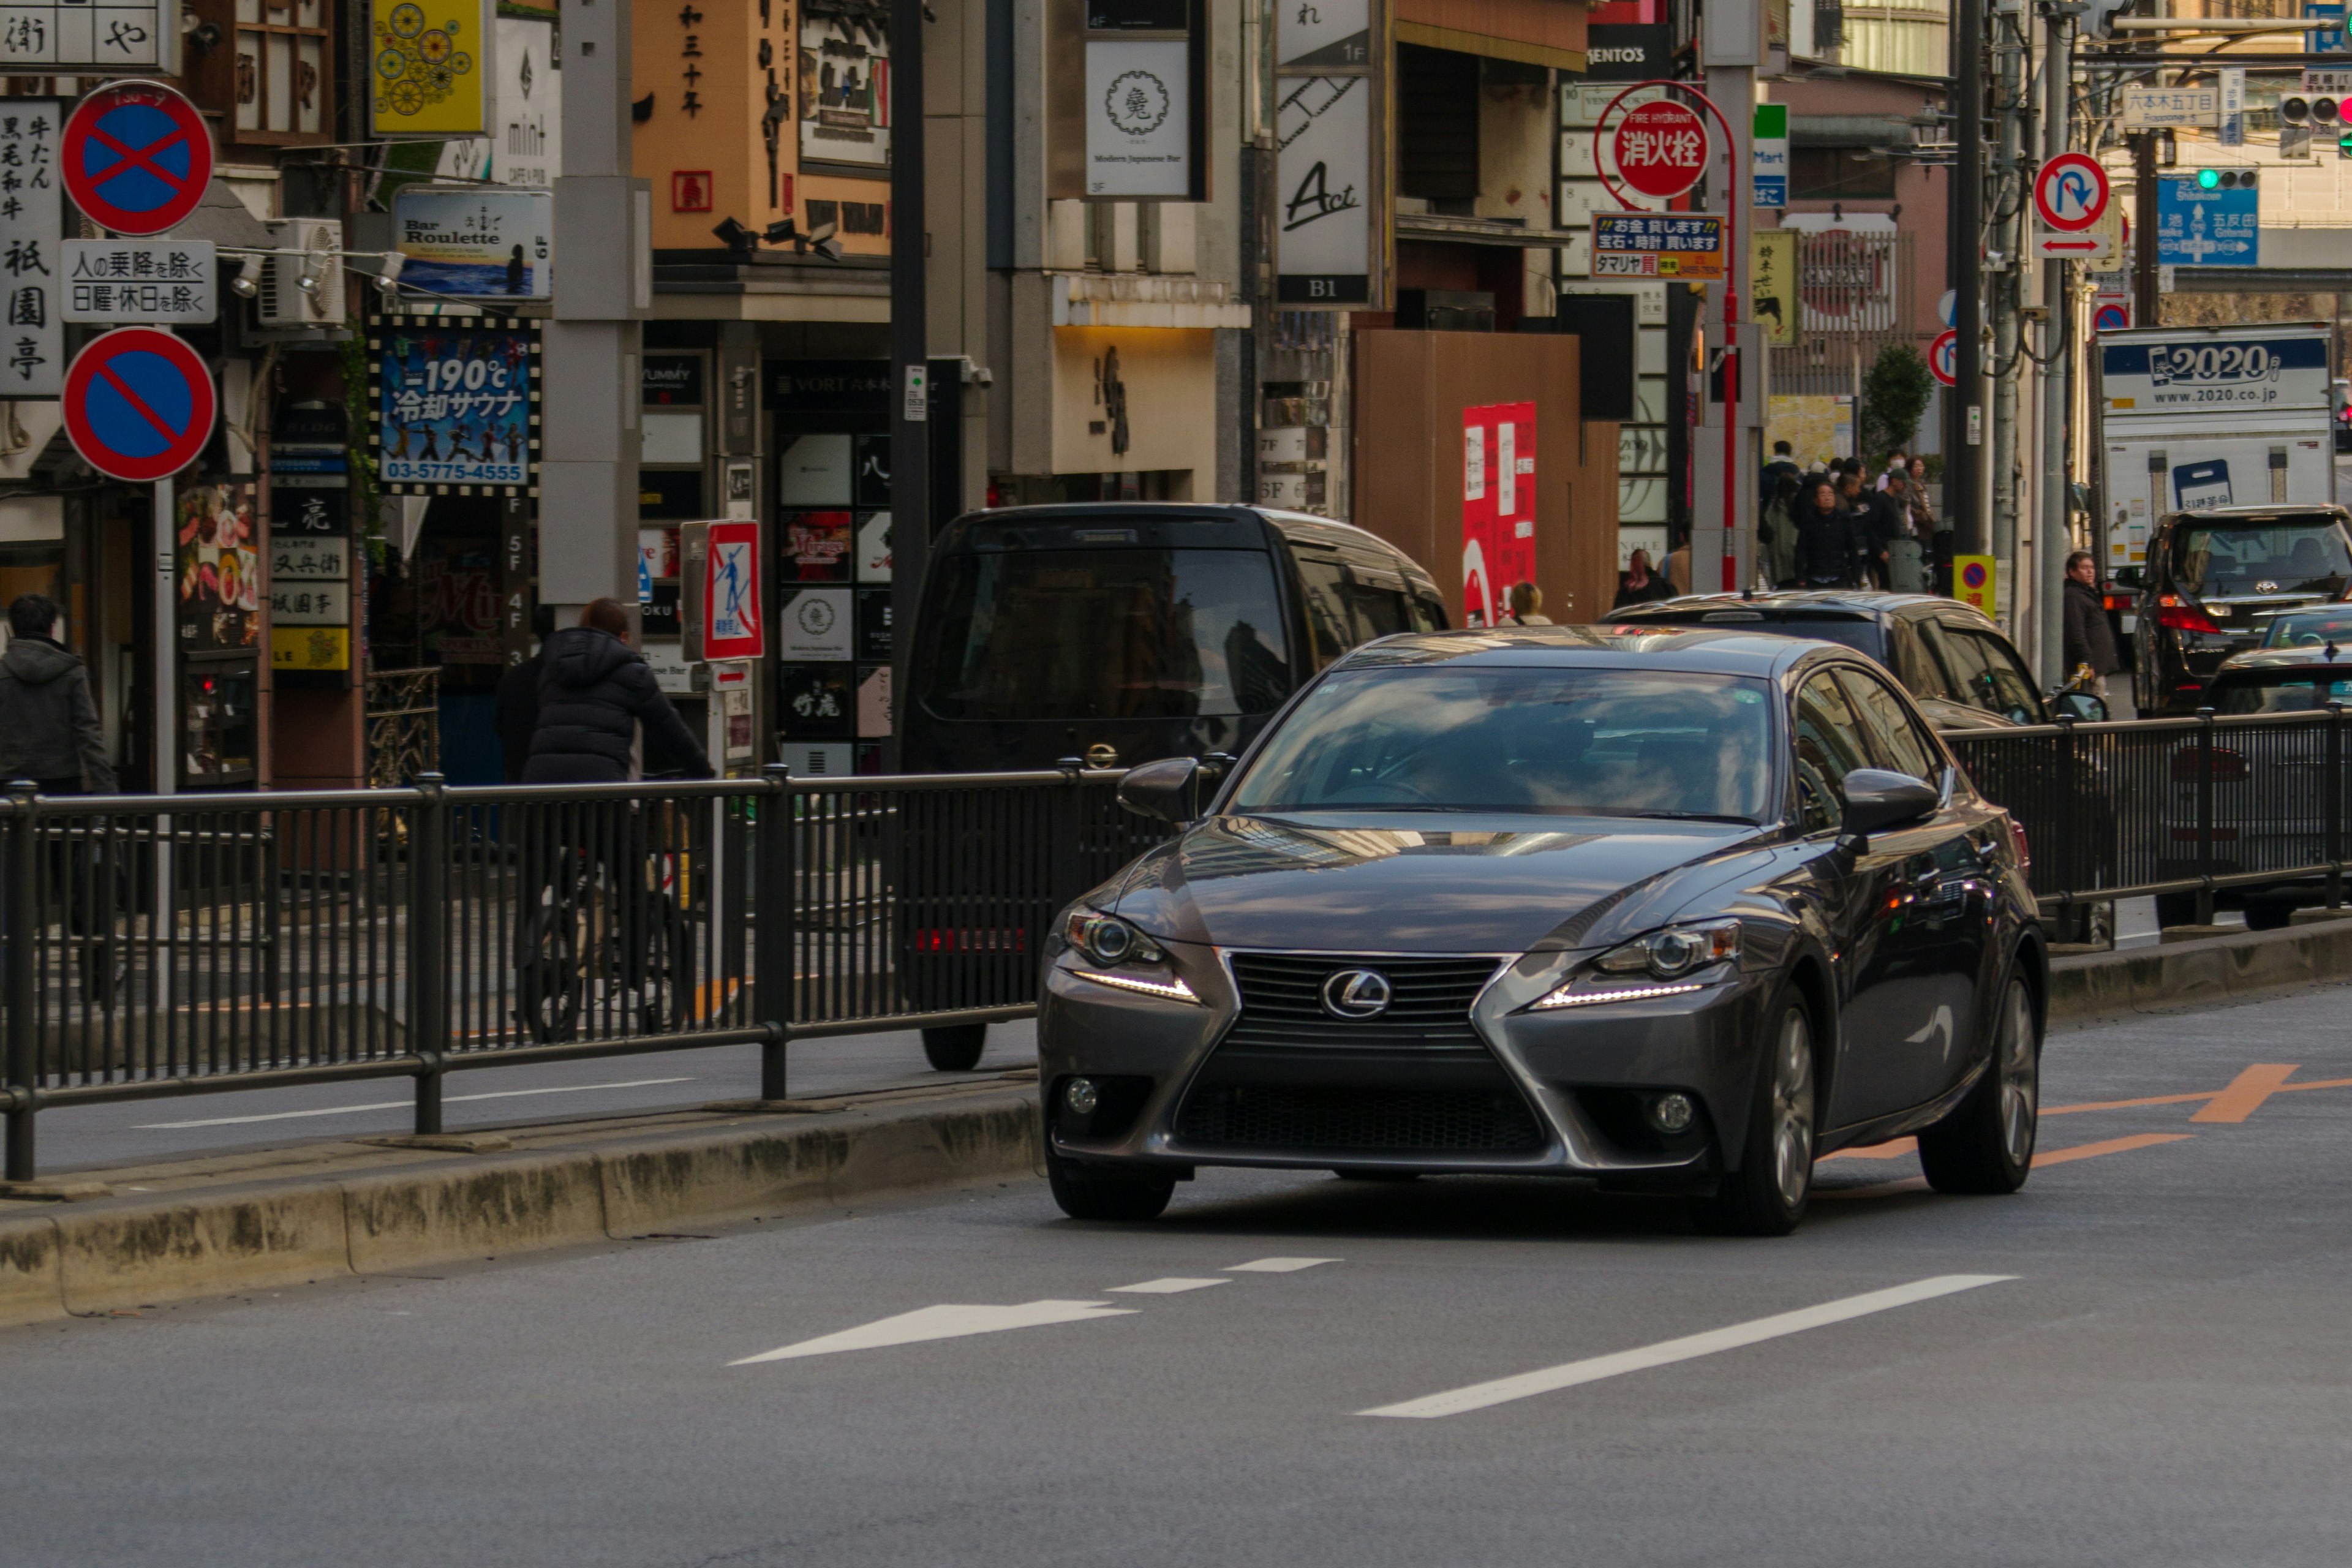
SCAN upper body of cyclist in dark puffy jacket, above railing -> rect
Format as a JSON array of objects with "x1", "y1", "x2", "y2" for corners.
[{"x1": 522, "y1": 600, "x2": 710, "y2": 783}]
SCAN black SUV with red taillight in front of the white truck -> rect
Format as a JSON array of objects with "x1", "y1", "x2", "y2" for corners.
[{"x1": 2131, "y1": 505, "x2": 2352, "y2": 715}]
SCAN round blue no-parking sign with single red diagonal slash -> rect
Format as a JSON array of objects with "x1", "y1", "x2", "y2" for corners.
[{"x1": 64, "y1": 326, "x2": 219, "y2": 482}]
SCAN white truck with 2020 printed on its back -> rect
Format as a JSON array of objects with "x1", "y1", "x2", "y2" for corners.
[{"x1": 2095, "y1": 322, "x2": 2335, "y2": 581}]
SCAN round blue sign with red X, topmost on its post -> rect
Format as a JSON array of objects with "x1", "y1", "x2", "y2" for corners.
[{"x1": 59, "y1": 82, "x2": 212, "y2": 235}]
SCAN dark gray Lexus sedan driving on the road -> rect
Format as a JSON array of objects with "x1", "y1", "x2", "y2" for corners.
[{"x1": 1037, "y1": 628, "x2": 2046, "y2": 1234}]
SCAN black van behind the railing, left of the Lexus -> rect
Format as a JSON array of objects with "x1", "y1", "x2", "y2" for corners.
[{"x1": 894, "y1": 501, "x2": 1447, "y2": 1069}]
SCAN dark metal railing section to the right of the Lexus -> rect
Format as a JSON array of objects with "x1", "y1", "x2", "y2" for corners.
[{"x1": 1943, "y1": 705, "x2": 2352, "y2": 924}]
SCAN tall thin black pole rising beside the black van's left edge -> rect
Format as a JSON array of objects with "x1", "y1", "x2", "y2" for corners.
[{"x1": 884, "y1": 0, "x2": 926, "y2": 769}]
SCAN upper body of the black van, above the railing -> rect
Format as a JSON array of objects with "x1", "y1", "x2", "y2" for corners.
[{"x1": 903, "y1": 501, "x2": 1447, "y2": 774}]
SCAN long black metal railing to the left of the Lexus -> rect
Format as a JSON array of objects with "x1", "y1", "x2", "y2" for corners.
[{"x1": 0, "y1": 766, "x2": 1167, "y2": 1180}]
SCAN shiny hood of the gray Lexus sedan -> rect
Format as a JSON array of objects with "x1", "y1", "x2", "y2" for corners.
[{"x1": 1094, "y1": 811, "x2": 1764, "y2": 952}]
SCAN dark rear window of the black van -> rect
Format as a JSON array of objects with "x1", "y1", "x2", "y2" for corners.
[{"x1": 922, "y1": 548, "x2": 1291, "y2": 722}]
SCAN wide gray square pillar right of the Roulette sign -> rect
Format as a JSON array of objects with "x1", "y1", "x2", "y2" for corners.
[{"x1": 538, "y1": 0, "x2": 654, "y2": 614}]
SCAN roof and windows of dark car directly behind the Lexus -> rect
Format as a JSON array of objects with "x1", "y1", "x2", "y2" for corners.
[{"x1": 1609, "y1": 590, "x2": 2108, "y2": 729}]
